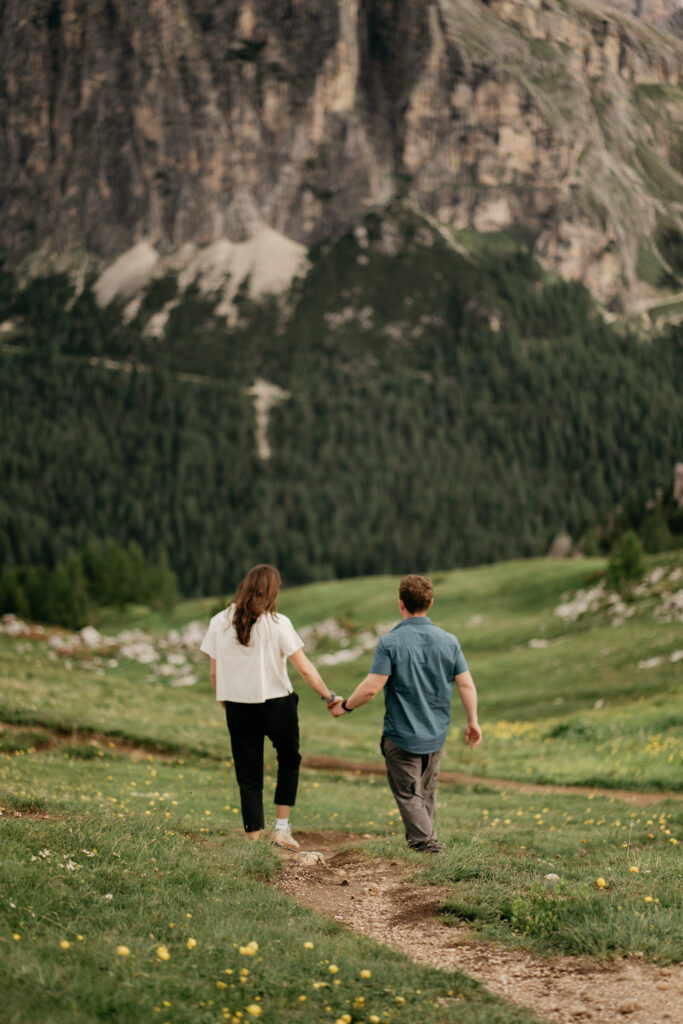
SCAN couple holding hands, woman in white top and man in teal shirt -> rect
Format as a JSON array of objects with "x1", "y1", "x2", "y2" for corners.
[{"x1": 200, "y1": 565, "x2": 481, "y2": 853}]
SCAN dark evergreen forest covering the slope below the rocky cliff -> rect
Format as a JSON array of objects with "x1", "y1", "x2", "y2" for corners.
[{"x1": 0, "y1": 211, "x2": 683, "y2": 610}]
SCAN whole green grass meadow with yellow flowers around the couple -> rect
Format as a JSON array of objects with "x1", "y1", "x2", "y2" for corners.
[{"x1": 0, "y1": 556, "x2": 683, "y2": 1024}]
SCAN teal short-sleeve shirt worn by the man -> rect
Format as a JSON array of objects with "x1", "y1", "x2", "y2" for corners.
[{"x1": 370, "y1": 615, "x2": 467, "y2": 754}]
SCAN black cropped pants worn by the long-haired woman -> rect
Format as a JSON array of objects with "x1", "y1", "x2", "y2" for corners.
[{"x1": 225, "y1": 693, "x2": 301, "y2": 831}]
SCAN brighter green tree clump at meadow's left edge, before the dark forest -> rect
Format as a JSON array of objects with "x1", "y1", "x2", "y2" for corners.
[{"x1": 0, "y1": 541, "x2": 178, "y2": 629}]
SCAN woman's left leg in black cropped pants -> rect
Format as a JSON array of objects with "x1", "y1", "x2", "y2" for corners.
[{"x1": 225, "y1": 700, "x2": 265, "y2": 839}]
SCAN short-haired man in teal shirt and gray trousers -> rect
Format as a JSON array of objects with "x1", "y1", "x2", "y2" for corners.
[{"x1": 330, "y1": 575, "x2": 481, "y2": 853}]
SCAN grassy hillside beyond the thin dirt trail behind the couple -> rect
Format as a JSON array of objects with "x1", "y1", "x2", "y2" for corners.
[{"x1": 0, "y1": 556, "x2": 683, "y2": 788}]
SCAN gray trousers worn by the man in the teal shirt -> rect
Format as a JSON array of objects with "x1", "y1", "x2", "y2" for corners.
[{"x1": 380, "y1": 736, "x2": 443, "y2": 853}]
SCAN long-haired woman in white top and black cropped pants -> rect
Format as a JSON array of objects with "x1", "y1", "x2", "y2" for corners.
[{"x1": 200, "y1": 565, "x2": 338, "y2": 850}]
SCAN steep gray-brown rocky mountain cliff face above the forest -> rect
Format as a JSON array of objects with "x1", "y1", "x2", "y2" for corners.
[{"x1": 0, "y1": 0, "x2": 683, "y2": 309}]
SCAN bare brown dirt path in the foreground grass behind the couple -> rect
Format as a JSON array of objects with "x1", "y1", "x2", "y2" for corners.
[{"x1": 273, "y1": 833, "x2": 683, "y2": 1024}]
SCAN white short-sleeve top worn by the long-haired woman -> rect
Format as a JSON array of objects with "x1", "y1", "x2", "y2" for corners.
[{"x1": 200, "y1": 604, "x2": 303, "y2": 703}]
